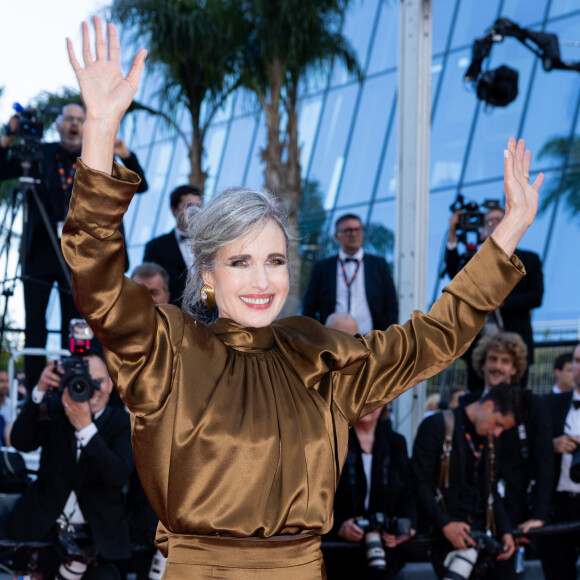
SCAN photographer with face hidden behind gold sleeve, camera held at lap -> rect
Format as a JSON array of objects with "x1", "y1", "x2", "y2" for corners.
[{"x1": 326, "y1": 408, "x2": 415, "y2": 580}]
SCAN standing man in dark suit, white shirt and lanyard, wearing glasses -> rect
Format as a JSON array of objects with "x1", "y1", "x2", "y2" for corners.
[{"x1": 302, "y1": 214, "x2": 399, "y2": 334}]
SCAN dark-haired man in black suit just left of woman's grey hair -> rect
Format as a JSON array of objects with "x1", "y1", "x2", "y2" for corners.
[{"x1": 143, "y1": 185, "x2": 202, "y2": 306}]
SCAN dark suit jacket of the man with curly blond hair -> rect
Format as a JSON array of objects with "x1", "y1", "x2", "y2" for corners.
[{"x1": 461, "y1": 386, "x2": 554, "y2": 527}]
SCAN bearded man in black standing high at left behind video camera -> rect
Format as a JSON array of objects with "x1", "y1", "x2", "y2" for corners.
[{"x1": 0, "y1": 104, "x2": 147, "y2": 389}]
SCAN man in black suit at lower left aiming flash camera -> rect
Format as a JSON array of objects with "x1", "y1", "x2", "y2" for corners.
[{"x1": 10, "y1": 351, "x2": 134, "y2": 580}]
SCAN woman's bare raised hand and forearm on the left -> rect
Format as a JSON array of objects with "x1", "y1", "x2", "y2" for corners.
[{"x1": 67, "y1": 16, "x2": 147, "y2": 175}]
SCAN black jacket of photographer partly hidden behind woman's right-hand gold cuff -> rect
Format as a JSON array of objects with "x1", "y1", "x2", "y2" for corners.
[{"x1": 445, "y1": 248, "x2": 544, "y2": 365}]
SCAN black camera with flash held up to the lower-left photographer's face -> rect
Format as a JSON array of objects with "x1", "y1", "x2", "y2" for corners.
[{"x1": 56, "y1": 318, "x2": 101, "y2": 403}]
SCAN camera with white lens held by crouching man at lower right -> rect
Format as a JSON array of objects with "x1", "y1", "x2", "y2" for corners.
[{"x1": 443, "y1": 530, "x2": 503, "y2": 580}]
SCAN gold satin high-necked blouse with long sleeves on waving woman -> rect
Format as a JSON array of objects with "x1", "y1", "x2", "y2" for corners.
[{"x1": 62, "y1": 160, "x2": 523, "y2": 538}]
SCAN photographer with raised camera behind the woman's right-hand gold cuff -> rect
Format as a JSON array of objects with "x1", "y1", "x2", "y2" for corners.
[{"x1": 445, "y1": 202, "x2": 544, "y2": 390}]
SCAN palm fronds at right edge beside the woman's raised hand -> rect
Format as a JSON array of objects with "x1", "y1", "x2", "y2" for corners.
[{"x1": 538, "y1": 136, "x2": 580, "y2": 217}]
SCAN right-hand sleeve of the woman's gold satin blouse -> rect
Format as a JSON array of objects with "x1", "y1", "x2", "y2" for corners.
[{"x1": 326, "y1": 238, "x2": 524, "y2": 424}]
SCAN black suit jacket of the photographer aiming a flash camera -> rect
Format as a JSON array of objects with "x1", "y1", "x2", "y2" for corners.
[{"x1": 9, "y1": 401, "x2": 134, "y2": 560}]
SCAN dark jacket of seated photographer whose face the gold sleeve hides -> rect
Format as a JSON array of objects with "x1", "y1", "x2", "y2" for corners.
[{"x1": 333, "y1": 421, "x2": 415, "y2": 534}]
